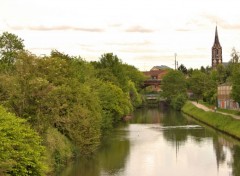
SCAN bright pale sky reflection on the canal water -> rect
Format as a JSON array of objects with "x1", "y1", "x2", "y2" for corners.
[{"x1": 118, "y1": 124, "x2": 231, "y2": 176}]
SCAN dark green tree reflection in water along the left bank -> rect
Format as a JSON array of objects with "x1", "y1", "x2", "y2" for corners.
[{"x1": 61, "y1": 129, "x2": 130, "y2": 176}]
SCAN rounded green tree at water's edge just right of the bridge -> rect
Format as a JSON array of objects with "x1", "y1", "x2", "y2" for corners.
[{"x1": 162, "y1": 70, "x2": 187, "y2": 110}]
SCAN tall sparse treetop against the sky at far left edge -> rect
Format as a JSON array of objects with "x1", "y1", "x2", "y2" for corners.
[{"x1": 0, "y1": 32, "x2": 24, "y2": 65}]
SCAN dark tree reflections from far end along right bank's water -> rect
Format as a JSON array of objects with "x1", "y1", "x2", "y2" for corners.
[{"x1": 136, "y1": 108, "x2": 240, "y2": 176}]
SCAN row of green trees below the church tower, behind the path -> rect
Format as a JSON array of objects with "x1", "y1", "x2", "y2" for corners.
[{"x1": 161, "y1": 49, "x2": 240, "y2": 110}]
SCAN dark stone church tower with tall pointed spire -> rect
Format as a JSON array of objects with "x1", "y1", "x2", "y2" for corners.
[{"x1": 212, "y1": 26, "x2": 222, "y2": 69}]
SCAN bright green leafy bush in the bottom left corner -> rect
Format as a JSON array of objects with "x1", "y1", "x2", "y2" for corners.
[{"x1": 0, "y1": 106, "x2": 46, "y2": 176}]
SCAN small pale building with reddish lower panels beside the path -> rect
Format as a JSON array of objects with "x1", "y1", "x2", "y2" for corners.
[{"x1": 217, "y1": 83, "x2": 239, "y2": 109}]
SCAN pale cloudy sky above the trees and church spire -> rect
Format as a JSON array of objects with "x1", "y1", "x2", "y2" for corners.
[{"x1": 0, "y1": 0, "x2": 240, "y2": 70}]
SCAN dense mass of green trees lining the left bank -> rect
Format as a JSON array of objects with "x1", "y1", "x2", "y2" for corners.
[{"x1": 0, "y1": 32, "x2": 144, "y2": 175}]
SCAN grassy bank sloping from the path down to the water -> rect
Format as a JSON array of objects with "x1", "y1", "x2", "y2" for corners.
[{"x1": 182, "y1": 102, "x2": 240, "y2": 139}]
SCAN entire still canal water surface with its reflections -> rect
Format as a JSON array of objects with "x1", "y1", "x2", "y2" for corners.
[{"x1": 61, "y1": 107, "x2": 240, "y2": 176}]
